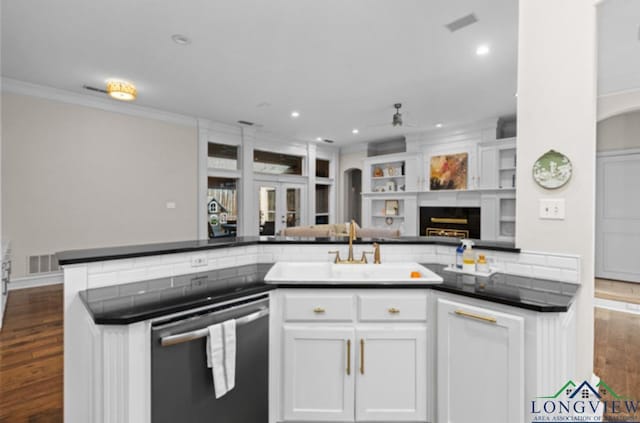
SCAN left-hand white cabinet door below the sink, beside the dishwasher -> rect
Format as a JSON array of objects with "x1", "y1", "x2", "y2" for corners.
[{"x1": 282, "y1": 326, "x2": 356, "y2": 422}]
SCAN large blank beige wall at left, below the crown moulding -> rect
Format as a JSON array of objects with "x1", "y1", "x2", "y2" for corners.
[{"x1": 1, "y1": 93, "x2": 197, "y2": 277}]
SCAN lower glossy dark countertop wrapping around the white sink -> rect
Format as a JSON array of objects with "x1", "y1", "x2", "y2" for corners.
[{"x1": 80, "y1": 264, "x2": 578, "y2": 325}]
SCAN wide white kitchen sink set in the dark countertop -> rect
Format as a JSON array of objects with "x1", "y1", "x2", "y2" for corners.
[{"x1": 264, "y1": 261, "x2": 442, "y2": 284}]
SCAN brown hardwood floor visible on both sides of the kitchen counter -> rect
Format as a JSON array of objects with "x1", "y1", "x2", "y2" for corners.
[{"x1": 0, "y1": 285, "x2": 640, "y2": 423}]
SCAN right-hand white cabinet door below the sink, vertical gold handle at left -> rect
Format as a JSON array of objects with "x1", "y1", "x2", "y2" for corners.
[{"x1": 356, "y1": 326, "x2": 427, "y2": 422}]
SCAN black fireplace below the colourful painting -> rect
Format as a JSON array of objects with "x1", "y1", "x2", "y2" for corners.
[{"x1": 420, "y1": 207, "x2": 480, "y2": 239}]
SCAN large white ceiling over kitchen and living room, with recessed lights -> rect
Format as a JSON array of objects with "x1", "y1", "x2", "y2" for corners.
[{"x1": 2, "y1": 0, "x2": 520, "y2": 144}]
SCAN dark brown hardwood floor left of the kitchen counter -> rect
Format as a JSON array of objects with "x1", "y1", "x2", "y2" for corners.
[{"x1": 0, "y1": 285, "x2": 63, "y2": 423}]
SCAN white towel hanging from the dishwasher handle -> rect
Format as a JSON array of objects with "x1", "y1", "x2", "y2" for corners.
[{"x1": 206, "y1": 320, "x2": 236, "y2": 398}]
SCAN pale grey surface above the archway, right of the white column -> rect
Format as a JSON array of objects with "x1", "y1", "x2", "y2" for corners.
[{"x1": 598, "y1": 0, "x2": 640, "y2": 95}]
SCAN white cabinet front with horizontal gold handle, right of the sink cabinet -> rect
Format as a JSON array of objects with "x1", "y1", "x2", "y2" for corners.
[{"x1": 436, "y1": 299, "x2": 524, "y2": 423}]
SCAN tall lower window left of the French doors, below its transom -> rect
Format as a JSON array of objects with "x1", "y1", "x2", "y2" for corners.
[{"x1": 207, "y1": 177, "x2": 238, "y2": 238}]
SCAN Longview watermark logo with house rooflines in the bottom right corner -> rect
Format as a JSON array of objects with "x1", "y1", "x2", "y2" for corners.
[{"x1": 529, "y1": 380, "x2": 640, "y2": 423}]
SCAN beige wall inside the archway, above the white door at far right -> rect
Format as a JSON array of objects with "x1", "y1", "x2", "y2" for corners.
[{"x1": 597, "y1": 111, "x2": 640, "y2": 151}]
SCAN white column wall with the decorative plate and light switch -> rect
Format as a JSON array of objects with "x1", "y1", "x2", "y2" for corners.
[{"x1": 516, "y1": 0, "x2": 596, "y2": 380}]
